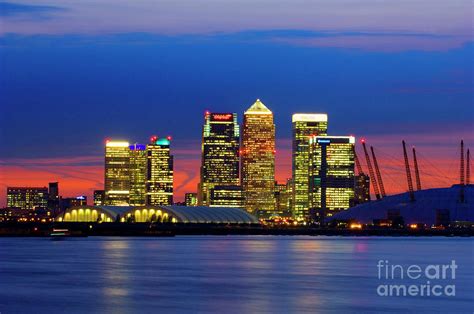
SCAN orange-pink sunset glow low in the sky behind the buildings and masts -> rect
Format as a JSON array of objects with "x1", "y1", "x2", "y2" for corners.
[{"x1": 0, "y1": 135, "x2": 474, "y2": 207}]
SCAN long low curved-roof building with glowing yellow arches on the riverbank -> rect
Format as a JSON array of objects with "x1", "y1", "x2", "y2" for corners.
[{"x1": 56, "y1": 206, "x2": 259, "y2": 224}]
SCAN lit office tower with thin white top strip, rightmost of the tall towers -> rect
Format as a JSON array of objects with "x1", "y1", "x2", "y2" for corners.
[{"x1": 309, "y1": 136, "x2": 355, "y2": 222}]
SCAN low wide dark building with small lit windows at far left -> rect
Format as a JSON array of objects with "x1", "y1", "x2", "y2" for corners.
[{"x1": 7, "y1": 187, "x2": 48, "y2": 210}]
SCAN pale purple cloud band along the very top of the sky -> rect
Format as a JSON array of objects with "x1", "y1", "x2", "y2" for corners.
[{"x1": 0, "y1": 0, "x2": 473, "y2": 51}]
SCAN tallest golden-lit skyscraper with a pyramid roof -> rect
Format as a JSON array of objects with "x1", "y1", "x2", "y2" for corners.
[{"x1": 241, "y1": 99, "x2": 276, "y2": 215}]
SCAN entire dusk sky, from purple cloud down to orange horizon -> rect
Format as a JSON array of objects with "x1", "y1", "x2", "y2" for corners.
[{"x1": 0, "y1": 0, "x2": 474, "y2": 206}]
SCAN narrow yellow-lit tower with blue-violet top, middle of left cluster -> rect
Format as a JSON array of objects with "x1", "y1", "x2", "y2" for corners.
[{"x1": 129, "y1": 144, "x2": 148, "y2": 206}]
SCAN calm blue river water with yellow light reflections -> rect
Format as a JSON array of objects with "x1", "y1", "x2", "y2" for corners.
[{"x1": 0, "y1": 236, "x2": 474, "y2": 314}]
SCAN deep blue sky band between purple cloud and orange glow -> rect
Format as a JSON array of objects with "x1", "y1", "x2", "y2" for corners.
[{"x1": 1, "y1": 32, "x2": 473, "y2": 157}]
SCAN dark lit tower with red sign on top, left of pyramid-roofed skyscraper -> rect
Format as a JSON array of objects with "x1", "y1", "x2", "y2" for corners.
[{"x1": 198, "y1": 112, "x2": 240, "y2": 206}]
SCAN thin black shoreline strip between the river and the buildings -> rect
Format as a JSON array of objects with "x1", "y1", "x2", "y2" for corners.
[{"x1": 0, "y1": 222, "x2": 474, "y2": 237}]
